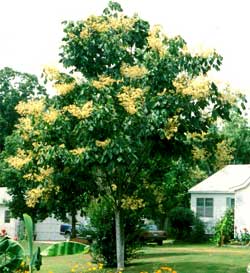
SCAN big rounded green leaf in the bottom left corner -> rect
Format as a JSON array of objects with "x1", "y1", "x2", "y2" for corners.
[{"x1": 0, "y1": 236, "x2": 25, "y2": 273}]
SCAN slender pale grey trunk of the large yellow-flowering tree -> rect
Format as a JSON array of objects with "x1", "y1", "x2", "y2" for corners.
[{"x1": 115, "y1": 209, "x2": 125, "y2": 272}]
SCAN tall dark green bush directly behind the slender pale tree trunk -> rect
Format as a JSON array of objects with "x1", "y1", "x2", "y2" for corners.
[{"x1": 87, "y1": 199, "x2": 142, "y2": 267}]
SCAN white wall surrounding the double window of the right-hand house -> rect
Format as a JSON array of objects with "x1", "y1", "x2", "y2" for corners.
[{"x1": 191, "y1": 193, "x2": 234, "y2": 234}]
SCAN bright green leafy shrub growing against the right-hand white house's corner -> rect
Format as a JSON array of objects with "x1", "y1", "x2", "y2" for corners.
[{"x1": 213, "y1": 209, "x2": 234, "y2": 246}]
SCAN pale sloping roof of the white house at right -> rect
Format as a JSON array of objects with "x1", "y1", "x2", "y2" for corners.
[{"x1": 189, "y1": 164, "x2": 250, "y2": 193}]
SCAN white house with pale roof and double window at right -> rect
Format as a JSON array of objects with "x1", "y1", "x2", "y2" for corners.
[{"x1": 189, "y1": 165, "x2": 250, "y2": 234}]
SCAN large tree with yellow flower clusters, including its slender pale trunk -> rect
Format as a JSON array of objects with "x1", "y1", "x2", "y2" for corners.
[{"x1": 1, "y1": 2, "x2": 244, "y2": 269}]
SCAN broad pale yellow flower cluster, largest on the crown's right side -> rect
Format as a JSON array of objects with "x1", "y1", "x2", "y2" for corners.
[{"x1": 173, "y1": 73, "x2": 210, "y2": 99}]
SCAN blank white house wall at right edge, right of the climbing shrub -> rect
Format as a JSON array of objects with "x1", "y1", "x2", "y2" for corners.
[{"x1": 234, "y1": 182, "x2": 250, "y2": 232}]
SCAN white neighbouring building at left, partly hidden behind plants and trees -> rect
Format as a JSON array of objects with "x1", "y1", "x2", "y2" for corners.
[{"x1": 0, "y1": 187, "x2": 86, "y2": 241}]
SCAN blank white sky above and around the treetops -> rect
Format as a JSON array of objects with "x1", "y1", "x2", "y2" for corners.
[{"x1": 0, "y1": 0, "x2": 250, "y2": 100}]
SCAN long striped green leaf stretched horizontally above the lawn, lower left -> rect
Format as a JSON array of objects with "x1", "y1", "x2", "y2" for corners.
[{"x1": 41, "y1": 242, "x2": 89, "y2": 256}]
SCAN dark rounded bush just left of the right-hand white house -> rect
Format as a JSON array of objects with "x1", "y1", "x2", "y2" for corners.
[{"x1": 169, "y1": 207, "x2": 206, "y2": 243}]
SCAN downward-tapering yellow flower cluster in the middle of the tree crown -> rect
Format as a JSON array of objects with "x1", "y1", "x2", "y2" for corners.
[{"x1": 117, "y1": 86, "x2": 143, "y2": 115}]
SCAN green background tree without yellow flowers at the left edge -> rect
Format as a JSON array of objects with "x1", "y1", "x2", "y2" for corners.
[{"x1": 0, "y1": 67, "x2": 45, "y2": 151}]
